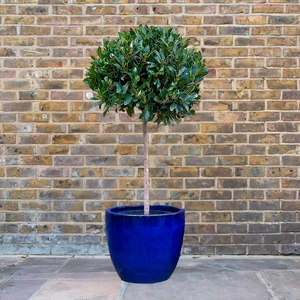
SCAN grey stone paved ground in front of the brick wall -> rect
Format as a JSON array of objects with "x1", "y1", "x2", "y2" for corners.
[{"x1": 0, "y1": 256, "x2": 300, "y2": 300}]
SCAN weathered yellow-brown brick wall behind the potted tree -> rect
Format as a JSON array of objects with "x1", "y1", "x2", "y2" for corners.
[{"x1": 0, "y1": 0, "x2": 300, "y2": 254}]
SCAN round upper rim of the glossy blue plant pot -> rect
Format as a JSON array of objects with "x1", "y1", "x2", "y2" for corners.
[{"x1": 105, "y1": 205, "x2": 185, "y2": 218}]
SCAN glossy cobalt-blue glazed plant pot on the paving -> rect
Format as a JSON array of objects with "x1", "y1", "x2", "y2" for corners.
[{"x1": 106, "y1": 205, "x2": 185, "y2": 283}]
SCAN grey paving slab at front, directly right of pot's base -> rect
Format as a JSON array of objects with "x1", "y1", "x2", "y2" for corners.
[{"x1": 123, "y1": 271, "x2": 270, "y2": 300}]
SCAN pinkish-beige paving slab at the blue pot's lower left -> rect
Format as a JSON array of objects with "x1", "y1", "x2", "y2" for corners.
[{"x1": 29, "y1": 272, "x2": 121, "y2": 300}]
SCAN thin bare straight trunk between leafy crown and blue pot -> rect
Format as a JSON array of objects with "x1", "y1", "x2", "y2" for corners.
[{"x1": 143, "y1": 122, "x2": 150, "y2": 215}]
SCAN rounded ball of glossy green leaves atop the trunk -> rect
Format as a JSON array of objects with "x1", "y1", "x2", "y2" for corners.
[{"x1": 84, "y1": 25, "x2": 207, "y2": 125}]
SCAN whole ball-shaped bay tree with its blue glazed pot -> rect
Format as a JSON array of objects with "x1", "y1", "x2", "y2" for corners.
[{"x1": 84, "y1": 25, "x2": 207, "y2": 283}]
